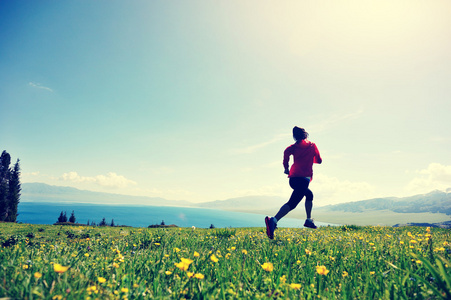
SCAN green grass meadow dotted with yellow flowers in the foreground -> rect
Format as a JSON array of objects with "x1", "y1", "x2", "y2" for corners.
[{"x1": 0, "y1": 223, "x2": 451, "y2": 299}]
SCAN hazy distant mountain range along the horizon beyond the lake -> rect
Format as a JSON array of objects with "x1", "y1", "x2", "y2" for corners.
[{"x1": 21, "y1": 183, "x2": 451, "y2": 221}]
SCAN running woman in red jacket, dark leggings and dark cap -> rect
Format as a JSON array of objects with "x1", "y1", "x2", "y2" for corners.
[{"x1": 265, "y1": 126, "x2": 323, "y2": 239}]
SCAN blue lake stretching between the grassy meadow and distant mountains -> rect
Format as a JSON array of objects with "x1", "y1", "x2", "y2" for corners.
[{"x1": 17, "y1": 202, "x2": 334, "y2": 228}]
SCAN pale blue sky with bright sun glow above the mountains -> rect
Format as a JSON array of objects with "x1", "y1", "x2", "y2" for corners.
[{"x1": 0, "y1": 0, "x2": 451, "y2": 205}]
